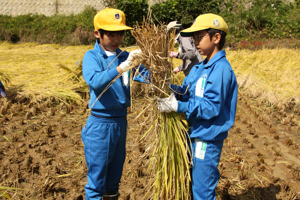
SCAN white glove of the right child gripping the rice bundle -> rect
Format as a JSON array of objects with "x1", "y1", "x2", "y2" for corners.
[{"x1": 157, "y1": 93, "x2": 178, "y2": 113}]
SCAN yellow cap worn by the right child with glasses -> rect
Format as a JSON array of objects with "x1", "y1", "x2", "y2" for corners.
[{"x1": 180, "y1": 13, "x2": 228, "y2": 37}]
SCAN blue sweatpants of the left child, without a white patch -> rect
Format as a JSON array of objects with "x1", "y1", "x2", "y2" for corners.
[{"x1": 81, "y1": 115, "x2": 127, "y2": 200}]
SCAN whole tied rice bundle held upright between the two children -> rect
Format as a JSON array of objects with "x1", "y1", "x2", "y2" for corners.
[{"x1": 131, "y1": 21, "x2": 191, "y2": 199}]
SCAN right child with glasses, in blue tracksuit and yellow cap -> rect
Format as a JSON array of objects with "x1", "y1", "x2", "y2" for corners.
[{"x1": 157, "y1": 14, "x2": 238, "y2": 200}]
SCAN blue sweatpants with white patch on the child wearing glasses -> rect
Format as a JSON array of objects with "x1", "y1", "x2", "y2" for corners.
[{"x1": 191, "y1": 138, "x2": 223, "y2": 200}]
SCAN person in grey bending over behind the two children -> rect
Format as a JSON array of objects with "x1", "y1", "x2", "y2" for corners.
[{"x1": 167, "y1": 21, "x2": 203, "y2": 76}]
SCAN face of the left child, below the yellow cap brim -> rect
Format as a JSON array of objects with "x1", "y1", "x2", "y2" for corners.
[{"x1": 94, "y1": 31, "x2": 125, "y2": 51}]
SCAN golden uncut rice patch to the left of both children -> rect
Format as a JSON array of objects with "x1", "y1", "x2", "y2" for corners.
[{"x1": 0, "y1": 43, "x2": 92, "y2": 103}]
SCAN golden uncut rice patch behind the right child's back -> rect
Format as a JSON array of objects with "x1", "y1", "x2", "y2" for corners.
[{"x1": 227, "y1": 49, "x2": 300, "y2": 106}]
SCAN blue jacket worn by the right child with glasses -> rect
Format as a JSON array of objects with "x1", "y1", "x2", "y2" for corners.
[{"x1": 171, "y1": 50, "x2": 238, "y2": 141}]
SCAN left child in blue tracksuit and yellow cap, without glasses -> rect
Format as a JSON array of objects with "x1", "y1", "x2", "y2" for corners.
[{"x1": 81, "y1": 8, "x2": 147, "y2": 200}]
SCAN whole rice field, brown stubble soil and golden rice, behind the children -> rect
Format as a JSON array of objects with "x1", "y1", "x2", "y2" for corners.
[{"x1": 0, "y1": 43, "x2": 300, "y2": 200}]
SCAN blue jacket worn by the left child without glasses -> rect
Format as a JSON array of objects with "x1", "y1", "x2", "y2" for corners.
[{"x1": 82, "y1": 42, "x2": 149, "y2": 117}]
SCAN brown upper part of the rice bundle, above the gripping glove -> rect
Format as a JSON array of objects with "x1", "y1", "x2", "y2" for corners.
[{"x1": 131, "y1": 21, "x2": 173, "y2": 97}]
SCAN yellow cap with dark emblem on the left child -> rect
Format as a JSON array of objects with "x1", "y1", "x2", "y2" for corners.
[{"x1": 94, "y1": 8, "x2": 132, "y2": 31}]
